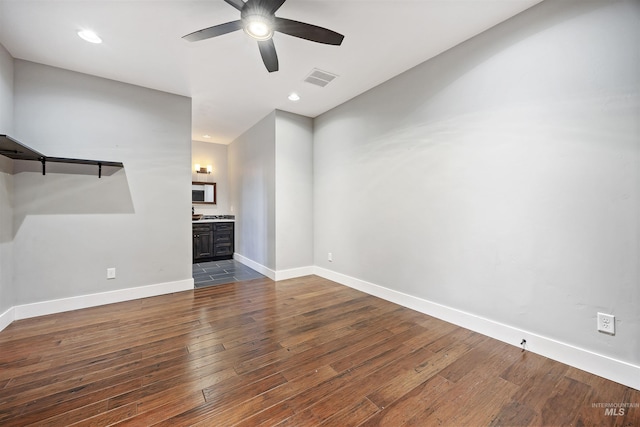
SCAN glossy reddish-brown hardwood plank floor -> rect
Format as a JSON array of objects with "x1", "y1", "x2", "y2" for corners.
[{"x1": 0, "y1": 276, "x2": 640, "y2": 427}]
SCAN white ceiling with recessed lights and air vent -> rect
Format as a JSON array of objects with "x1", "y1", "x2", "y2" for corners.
[{"x1": 0, "y1": 0, "x2": 541, "y2": 144}]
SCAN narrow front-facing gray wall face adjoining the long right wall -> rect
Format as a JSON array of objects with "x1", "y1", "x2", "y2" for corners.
[{"x1": 275, "y1": 111, "x2": 313, "y2": 270}]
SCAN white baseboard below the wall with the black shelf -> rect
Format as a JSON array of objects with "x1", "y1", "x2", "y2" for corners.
[{"x1": 8, "y1": 279, "x2": 193, "y2": 322}]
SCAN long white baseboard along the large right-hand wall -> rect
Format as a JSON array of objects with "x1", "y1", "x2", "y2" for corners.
[{"x1": 314, "y1": 267, "x2": 640, "y2": 390}]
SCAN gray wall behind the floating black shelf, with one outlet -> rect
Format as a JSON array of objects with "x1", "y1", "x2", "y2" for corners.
[{"x1": 13, "y1": 60, "x2": 191, "y2": 305}]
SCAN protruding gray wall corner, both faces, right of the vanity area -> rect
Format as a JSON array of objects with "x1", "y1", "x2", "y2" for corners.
[{"x1": 228, "y1": 111, "x2": 313, "y2": 271}]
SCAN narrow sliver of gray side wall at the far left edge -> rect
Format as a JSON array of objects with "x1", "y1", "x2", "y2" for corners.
[{"x1": 0, "y1": 44, "x2": 13, "y2": 314}]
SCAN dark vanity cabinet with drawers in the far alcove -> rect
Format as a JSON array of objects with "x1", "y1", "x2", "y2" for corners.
[{"x1": 193, "y1": 222, "x2": 234, "y2": 263}]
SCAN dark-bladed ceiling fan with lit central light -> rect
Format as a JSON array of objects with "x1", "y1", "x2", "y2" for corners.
[{"x1": 182, "y1": 0, "x2": 344, "y2": 73}]
